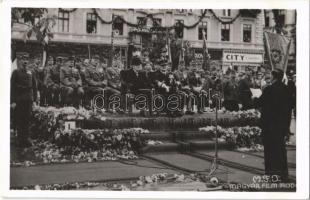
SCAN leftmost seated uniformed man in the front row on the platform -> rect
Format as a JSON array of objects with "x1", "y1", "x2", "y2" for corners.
[{"x1": 44, "y1": 56, "x2": 62, "y2": 106}]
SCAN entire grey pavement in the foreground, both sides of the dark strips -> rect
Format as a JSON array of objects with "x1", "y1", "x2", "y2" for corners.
[{"x1": 10, "y1": 146, "x2": 296, "y2": 187}]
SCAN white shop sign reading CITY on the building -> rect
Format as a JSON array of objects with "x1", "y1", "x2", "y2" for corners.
[{"x1": 223, "y1": 52, "x2": 263, "y2": 63}]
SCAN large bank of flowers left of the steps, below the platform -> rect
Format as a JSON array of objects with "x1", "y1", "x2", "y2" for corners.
[{"x1": 11, "y1": 128, "x2": 148, "y2": 167}]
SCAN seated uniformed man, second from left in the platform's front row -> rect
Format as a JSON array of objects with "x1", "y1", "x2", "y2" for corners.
[{"x1": 60, "y1": 57, "x2": 84, "y2": 107}]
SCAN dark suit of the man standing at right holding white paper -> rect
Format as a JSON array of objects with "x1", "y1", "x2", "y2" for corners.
[{"x1": 254, "y1": 81, "x2": 291, "y2": 178}]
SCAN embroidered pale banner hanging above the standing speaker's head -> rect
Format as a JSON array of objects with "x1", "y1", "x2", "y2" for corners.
[{"x1": 264, "y1": 32, "x2": 291, "y2": 73}]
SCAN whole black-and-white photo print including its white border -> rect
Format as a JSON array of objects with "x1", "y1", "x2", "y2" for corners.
[{"x1": 2, "y1": 1, "x2": 309, "y2": 198}]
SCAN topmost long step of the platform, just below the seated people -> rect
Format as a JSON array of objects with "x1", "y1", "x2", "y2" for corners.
[{"x1": 80, "y1": 113, "x2": 258, "y2": 130}]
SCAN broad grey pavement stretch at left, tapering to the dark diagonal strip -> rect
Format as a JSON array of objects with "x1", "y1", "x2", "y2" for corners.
[{"x1": 10, "y1": 160, "x2": 178, "y2": 187}]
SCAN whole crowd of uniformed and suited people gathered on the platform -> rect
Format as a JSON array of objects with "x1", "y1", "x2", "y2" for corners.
[{"x1": 10, "y1": 52, "x2": 292, "y2": 114}]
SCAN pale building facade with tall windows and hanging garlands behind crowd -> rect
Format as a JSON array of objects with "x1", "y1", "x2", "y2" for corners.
[{"x1": 12, "y1": 8, "x2": 265, "y2": 70}]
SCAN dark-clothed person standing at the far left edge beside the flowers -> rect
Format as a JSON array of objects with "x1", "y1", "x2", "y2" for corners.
[{"x1": 11, "y1": 55, "x2": 37, "y2": 147}]
